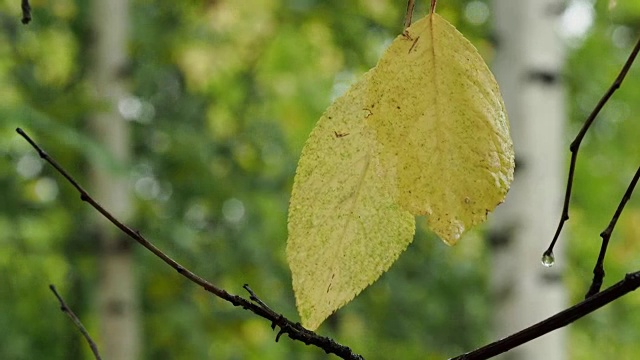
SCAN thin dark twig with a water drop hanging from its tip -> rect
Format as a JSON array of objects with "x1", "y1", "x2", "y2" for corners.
[{"x1": 543, "y1": 35, "x2": 640, "y2": 257}]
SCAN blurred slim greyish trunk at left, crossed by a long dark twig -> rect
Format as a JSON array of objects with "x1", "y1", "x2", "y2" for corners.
[{"x1": 90, "y1": 0, "x2": 140, "y2": 360}]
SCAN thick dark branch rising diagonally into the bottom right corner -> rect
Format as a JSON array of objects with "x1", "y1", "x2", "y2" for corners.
[{"x1": 451, "y1": 271, "x2": 640, "y2": 360}]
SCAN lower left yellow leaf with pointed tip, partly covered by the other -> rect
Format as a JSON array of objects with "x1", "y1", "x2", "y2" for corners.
[{"x1": 287, "y1": 71, "x2": 415, "y2": 329}]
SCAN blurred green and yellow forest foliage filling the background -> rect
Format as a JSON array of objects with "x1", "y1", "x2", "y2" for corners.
[{"x1": 0, "y1": 0, "x2": 640, "y2": 359}]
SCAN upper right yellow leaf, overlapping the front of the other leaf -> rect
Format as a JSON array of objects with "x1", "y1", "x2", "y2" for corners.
[{"x1": 368, "y1": 13, "x2": 514, "y2": 245}]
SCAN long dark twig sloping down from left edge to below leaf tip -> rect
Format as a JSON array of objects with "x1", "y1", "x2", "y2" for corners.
[{"x1": 16, "y1": 128, "x2": 364, "y2": 360}]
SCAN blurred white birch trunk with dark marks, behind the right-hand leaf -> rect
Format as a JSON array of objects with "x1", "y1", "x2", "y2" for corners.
[{"x1": 490, "y1": 0, "x2": 569, "y2": 360}]
